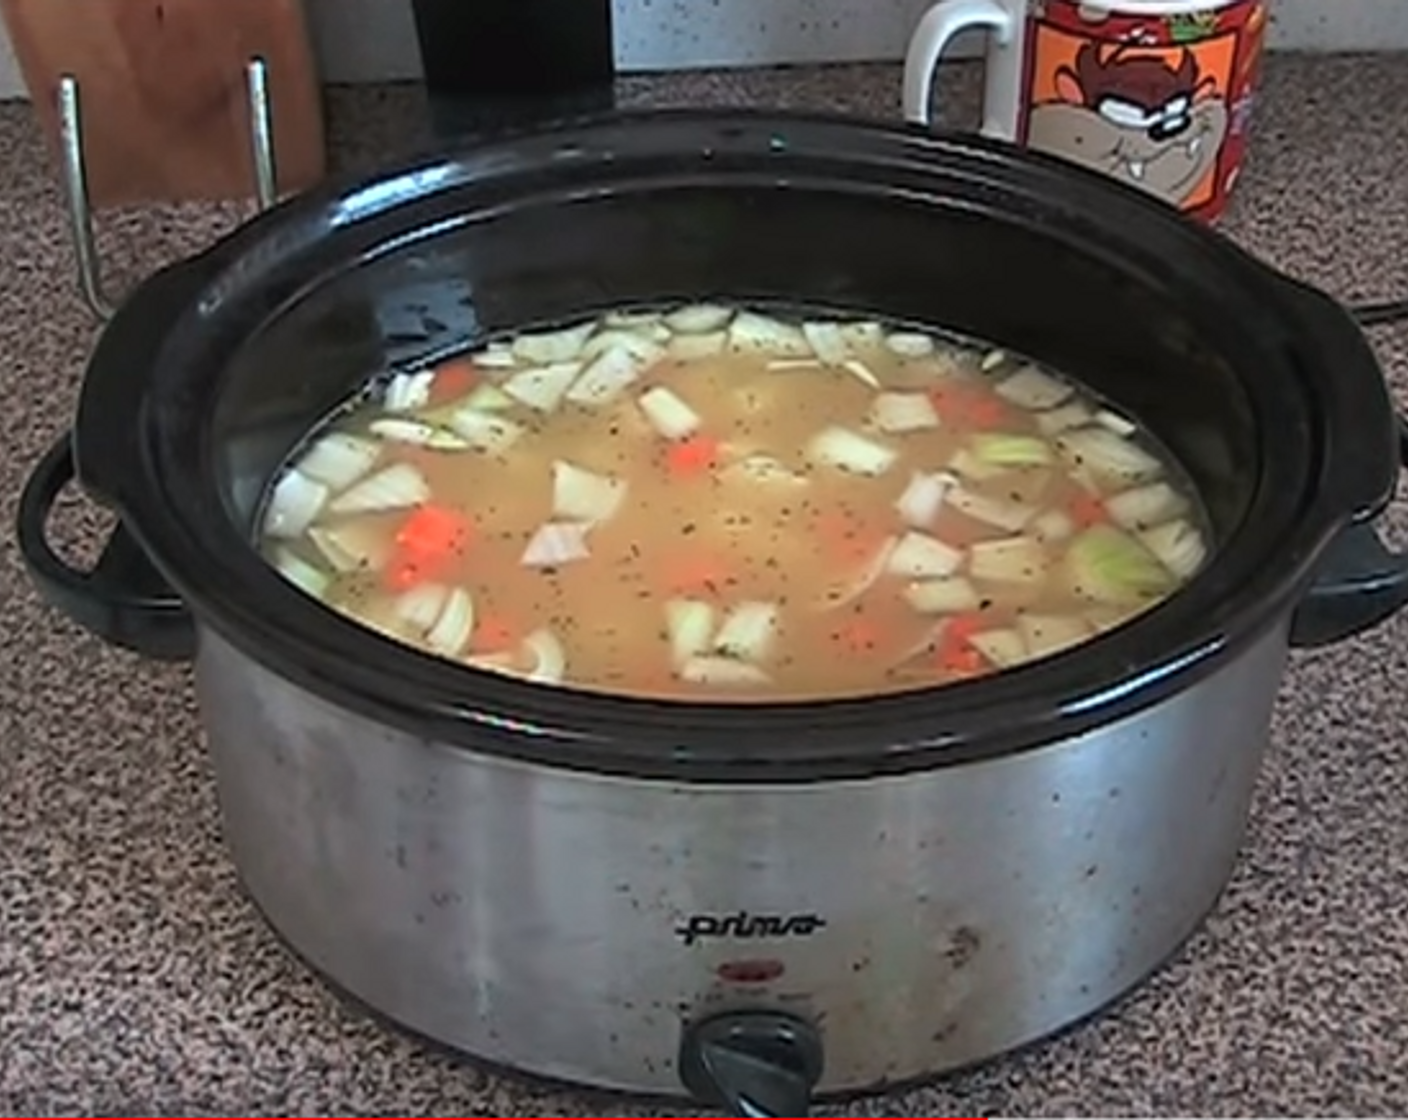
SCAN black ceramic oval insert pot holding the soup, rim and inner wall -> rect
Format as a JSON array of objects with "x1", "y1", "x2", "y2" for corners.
[{"x1": 13, "y1": 111, "x2": 1398, "y2": 782}]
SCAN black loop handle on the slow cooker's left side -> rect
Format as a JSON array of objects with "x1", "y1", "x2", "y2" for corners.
[{"x1": 17, "y1": 431, "x2": 196, "y2": 661}]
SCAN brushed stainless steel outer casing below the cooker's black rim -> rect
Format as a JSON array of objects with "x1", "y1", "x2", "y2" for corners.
[{"x1": 196, "y1": 628, "x2": 1286, "y2": 1098}]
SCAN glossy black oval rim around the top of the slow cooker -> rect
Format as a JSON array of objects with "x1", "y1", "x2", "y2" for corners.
[{"x1": 79, "y1": 110, "x2": 1393, "y2": 783}]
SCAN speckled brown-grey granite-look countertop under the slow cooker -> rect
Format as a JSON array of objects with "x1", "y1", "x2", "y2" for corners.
[{"x1": 0, "y1": 55, "x2": 1408, "y2": 1116}]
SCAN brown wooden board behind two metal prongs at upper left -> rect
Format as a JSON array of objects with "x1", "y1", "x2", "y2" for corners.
[{"x1": 0, "y1": 0, "x2": 325, "y2": 207}]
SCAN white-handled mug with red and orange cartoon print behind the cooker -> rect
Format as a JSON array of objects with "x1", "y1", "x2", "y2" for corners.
[{"x1": 904, "y1": 0, "x2": 1267, "y2": 220}]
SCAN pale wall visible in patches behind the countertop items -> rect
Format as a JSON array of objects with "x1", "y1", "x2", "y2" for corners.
[{"x1": 0, "y1": 0, "x2": 1408, "y2": 97}]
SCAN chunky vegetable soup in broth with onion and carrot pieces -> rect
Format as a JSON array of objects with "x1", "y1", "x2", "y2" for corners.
[{"x1": 259, "y1": 304, "x2": 1207, "y2": 702}]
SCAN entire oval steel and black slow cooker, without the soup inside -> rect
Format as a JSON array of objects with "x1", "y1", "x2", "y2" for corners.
[{"x1": 20, "y1": 111, "x2": 1408, "y2": 1114}]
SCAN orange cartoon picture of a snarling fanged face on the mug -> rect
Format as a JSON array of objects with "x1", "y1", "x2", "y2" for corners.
[{"x1": 1026, "y1": 28, "x2": 1238, "y2": 210}]
